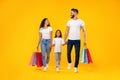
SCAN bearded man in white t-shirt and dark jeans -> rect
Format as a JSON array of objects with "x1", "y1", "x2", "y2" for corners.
[{"x1": 64, "y1": 8, "x2": 86, "y2": 73}]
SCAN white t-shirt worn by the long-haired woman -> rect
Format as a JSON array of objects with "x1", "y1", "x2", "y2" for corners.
[{"x1": 39, "y1": 27, "x2": 52, "y2": 39}]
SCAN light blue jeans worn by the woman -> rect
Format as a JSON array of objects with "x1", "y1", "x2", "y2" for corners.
[{"x1": 41, "y1": 39, "x2": 51, "y2": 67}]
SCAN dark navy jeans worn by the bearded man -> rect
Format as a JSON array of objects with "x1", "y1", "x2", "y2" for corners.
[{"x1": 67, "y1": 40, "x2": 81, "y2": 67}]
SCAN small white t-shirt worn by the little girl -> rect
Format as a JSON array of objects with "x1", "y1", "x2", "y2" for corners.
[{"x1": 53, "y1": 38, "x2": 64, "y2": 52}]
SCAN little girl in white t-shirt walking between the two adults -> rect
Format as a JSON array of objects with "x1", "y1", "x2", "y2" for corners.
[{"x1": 53, "y1": 30, "x2": 65, "y2": 72}]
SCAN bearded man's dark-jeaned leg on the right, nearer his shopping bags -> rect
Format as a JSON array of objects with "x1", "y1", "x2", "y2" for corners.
[{"x1": 74, "y1": 40, "x2": 80, "y2": 68}]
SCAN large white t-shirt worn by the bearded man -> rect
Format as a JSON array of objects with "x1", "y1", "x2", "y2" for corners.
[{"x1": 67, "y1": 19, "x2": 85, "y2": 40}]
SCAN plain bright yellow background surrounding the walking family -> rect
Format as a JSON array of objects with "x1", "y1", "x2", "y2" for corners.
[{"x1": 0, "y1": 0, "x2": 120, "y2": 80}]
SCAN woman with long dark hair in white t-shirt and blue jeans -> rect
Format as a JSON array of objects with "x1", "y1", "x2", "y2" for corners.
[{"x1": 37, "y1": 18, "x2": 52, "y2": 71}]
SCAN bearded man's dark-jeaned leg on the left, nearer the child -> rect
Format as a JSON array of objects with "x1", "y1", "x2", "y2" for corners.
[{"x1": 67, "y1": 40, "x2": 73, "y2": 63}]
